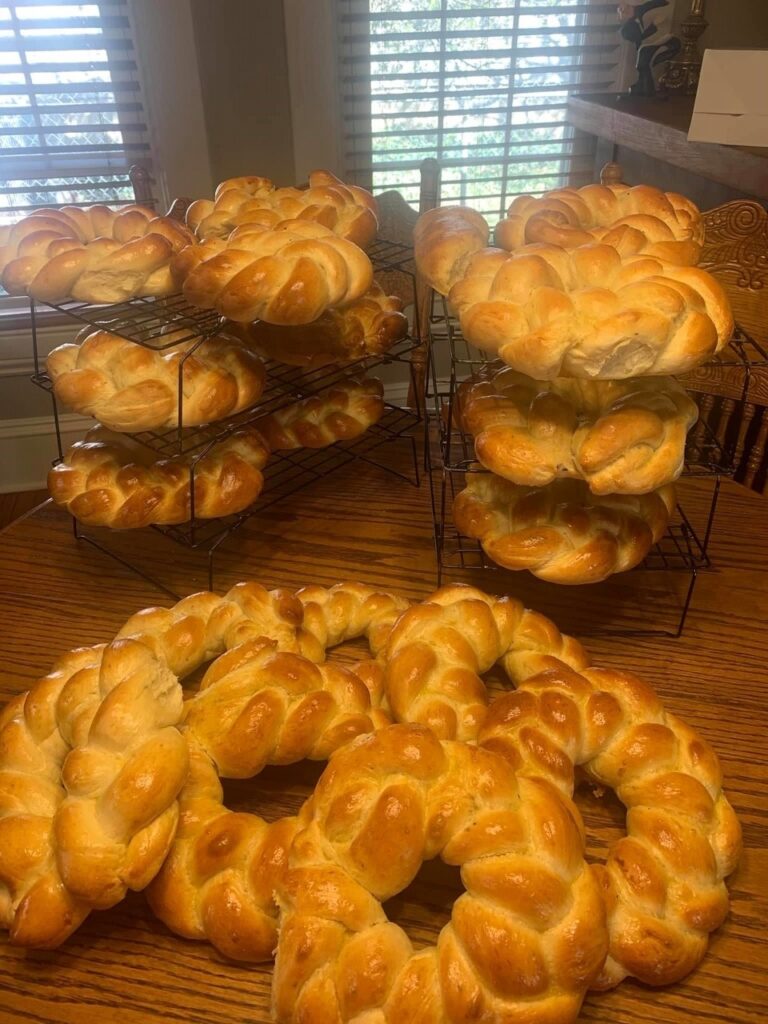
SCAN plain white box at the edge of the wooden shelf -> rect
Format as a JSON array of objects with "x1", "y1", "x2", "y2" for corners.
[{"x1": 688, "y1": 50, "x2": 768, "y2": 146}]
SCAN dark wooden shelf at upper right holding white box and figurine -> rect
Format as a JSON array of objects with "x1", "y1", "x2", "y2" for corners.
[{"x1": 567, "y1": 93, "x2": 768, "y2": 200}]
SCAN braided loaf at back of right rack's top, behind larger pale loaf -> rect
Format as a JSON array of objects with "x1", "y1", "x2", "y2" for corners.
[{"x1": 495, "y1": 184, "x2": 703, "y2": 266}]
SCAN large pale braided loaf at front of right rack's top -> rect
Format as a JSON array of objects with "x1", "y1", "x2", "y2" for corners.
[{"x1": 449, "y1": 245, "x2": 733, "y2": 380}]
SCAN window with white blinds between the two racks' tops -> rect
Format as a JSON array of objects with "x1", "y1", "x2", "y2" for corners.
[{"x1": 337, "y1": 0, "x2": 620, "y2": 216}]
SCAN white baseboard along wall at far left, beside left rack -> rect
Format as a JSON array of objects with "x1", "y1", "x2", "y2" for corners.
[{"x1": 0, "y1": 413, "x2": 93, "y2": 495}]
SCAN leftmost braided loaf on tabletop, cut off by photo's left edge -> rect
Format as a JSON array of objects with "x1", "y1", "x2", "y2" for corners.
[{"x1": 0, "y1": 640, "x2": 187, "y2": 948}]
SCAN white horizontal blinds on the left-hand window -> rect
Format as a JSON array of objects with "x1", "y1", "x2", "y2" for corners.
[{"x1": 0, "y1": 0, "x2": 150, "y2": 223}]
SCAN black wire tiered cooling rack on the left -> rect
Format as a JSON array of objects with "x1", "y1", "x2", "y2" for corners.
[{"x1": 31, "y1": 240, "x2": 423, "y2": 590}]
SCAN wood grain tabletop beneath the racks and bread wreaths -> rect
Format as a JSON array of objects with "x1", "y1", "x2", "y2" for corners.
[{"x1": 0, "y1": 464, "x2": 768, "y2": 1024}]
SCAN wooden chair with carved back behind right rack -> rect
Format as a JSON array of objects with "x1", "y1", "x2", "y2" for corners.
[{"x1": 681, "y1": 200, "x2": 768, "y2": 490}]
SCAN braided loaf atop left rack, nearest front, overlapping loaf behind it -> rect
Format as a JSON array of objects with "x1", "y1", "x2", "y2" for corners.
[{"x1": 171, "y1": 220, "x2": 373, "y2": 325}]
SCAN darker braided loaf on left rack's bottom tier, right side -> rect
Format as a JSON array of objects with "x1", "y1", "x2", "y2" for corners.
[{"x1": 254, "y1": 377, "x2": 385, "y2": 452}]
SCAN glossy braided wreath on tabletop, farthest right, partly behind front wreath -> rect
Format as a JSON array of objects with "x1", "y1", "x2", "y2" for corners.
[{"x1": 479, "y1": 666, "x2": 740, "y2": 988}]
